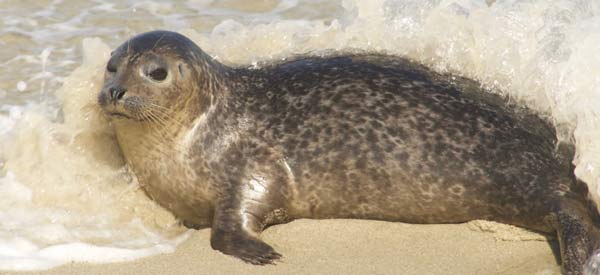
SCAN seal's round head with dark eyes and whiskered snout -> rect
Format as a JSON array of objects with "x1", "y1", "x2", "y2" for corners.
[{"x1": 98, "y1": 31, "x2": 214, "y2": 121}]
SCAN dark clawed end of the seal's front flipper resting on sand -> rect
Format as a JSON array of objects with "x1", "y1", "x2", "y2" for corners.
[{"x1": 210, "y1": 228, "x2": 281, "y2": 265}]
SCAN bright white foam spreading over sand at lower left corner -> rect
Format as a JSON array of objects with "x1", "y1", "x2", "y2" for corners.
[{"x1": 0, "y1": 168, "x2": 191, "y2": 270}]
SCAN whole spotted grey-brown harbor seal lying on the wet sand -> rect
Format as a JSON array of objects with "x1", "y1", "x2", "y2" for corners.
[{"x1": 98, "y1": 31, "x2": 600, "y2": 274}]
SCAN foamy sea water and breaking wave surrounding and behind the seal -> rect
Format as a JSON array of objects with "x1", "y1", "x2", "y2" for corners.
[{"x1": 0, "y1": 0, "x2": 600, "y2": 270}]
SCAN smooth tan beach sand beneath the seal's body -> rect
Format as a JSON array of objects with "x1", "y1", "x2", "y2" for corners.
[{"x1": 9, "y1": 220, "x2": 560, "y2": 275}]
